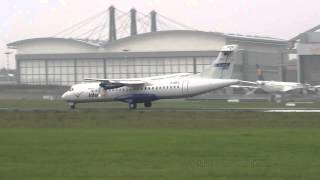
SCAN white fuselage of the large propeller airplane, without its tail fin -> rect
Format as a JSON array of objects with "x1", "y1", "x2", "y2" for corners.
[{"x1": 62, "y1": 76, "x2": 239, "y2": 103}]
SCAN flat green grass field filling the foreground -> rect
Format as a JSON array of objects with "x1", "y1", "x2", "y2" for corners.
[{"x1": 0, "y1": 101, "x2": 320, "y2": 180}]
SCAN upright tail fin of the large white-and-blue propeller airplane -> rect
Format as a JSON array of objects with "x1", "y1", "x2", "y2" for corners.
[{"x1": 199, "y1": 45, "x2": 238, "y2": 79}]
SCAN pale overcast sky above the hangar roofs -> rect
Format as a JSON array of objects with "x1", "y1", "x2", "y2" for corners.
[{"x1": 0, "y1": 0, "x2": 320, "y2": 68}]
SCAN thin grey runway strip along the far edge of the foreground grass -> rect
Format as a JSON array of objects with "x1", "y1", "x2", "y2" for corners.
[{"x1": 0, "y1": 108, "x2": 320, "y2": 113}]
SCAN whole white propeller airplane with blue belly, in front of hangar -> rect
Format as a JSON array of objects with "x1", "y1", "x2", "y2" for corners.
[{"x1": 62, "y1": 45, "x2": 240, "y2": 109}]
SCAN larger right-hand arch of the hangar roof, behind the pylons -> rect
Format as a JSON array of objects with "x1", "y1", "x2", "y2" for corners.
[{"x1": 102, "y1": 30, "x2": 225, "y2": 52}]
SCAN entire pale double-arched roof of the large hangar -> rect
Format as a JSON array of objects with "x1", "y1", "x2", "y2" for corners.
[{"x1": 8, "y1": 30, "x2": 288, "y2": 54}]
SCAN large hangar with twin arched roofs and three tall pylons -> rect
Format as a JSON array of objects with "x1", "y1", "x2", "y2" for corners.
[{"x1": 8, "y1": 7, "x2": 288, "y2": 86}]
